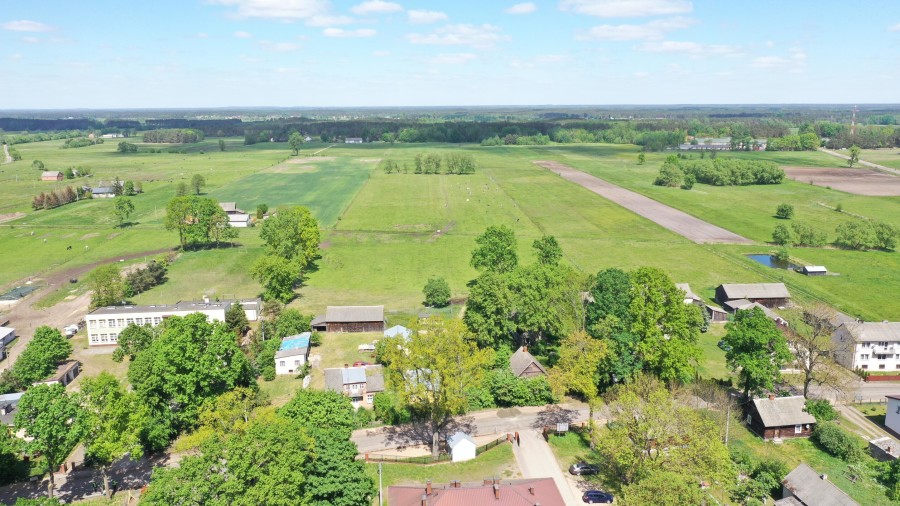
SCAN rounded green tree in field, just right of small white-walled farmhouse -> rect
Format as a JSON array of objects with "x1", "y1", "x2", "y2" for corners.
[{"x1": 259, "y1": 206, "x2": 320, "y2": 269}]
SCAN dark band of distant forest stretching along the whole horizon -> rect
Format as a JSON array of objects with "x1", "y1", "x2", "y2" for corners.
[{"x1": 0, "y1": 106, "x2": 900, "y2": 151}]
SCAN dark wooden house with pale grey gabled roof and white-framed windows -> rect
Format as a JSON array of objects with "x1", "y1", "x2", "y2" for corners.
[{"x1": 747, "y1": 394, "x2": 816, "y2": 441}]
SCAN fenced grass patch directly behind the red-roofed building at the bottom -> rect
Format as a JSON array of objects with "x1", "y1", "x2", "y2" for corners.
[{"x1": 366, "y1": 444, "x2": 521, "y2": 506}]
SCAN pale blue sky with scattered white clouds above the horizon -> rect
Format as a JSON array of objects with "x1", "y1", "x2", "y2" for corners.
[{"x1": 0, "y1": 0, "x2": 900, "y2": 109}]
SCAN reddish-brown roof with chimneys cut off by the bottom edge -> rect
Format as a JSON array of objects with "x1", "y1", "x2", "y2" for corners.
[{"x1": 388, "y1": 478, "x2": 566, "y2": 506}]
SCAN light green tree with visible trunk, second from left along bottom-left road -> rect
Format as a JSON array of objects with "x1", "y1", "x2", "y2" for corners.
[{"x1": 81, "y1": 371, "x2": 150, "y2": 500}]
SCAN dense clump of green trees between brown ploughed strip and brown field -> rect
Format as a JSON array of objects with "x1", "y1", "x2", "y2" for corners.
[{"x1": 653, "y1": 155, "x2": 784, "y2": 189}]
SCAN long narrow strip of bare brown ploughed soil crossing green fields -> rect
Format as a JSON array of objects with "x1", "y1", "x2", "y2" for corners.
[{"x1": 534, "y1": 161, "x2": 753, "y2": 244}]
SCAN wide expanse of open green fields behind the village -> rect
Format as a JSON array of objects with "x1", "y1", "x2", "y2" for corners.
[{"x1": 0, "y1": 139, "x2": 900, "y2": 319}]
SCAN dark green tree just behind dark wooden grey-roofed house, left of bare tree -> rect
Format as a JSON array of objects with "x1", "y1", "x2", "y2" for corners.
[{"x1": 722, "y1": 307, "x2": 791, "y2": 399}]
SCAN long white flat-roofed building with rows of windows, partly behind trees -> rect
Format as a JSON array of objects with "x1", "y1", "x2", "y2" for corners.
[{"x1": 84, "y1": 299, "x2": 262, "y2": 346}]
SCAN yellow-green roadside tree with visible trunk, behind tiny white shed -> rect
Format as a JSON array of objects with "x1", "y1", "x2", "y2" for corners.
[{"x1": 382, "y1": 317, "x2": 491, "y2": 458}]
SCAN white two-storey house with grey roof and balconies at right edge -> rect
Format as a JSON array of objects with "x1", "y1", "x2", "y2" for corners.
[{"x1": 831, "y1": 320, "x2": 900, "y2": 371}]
